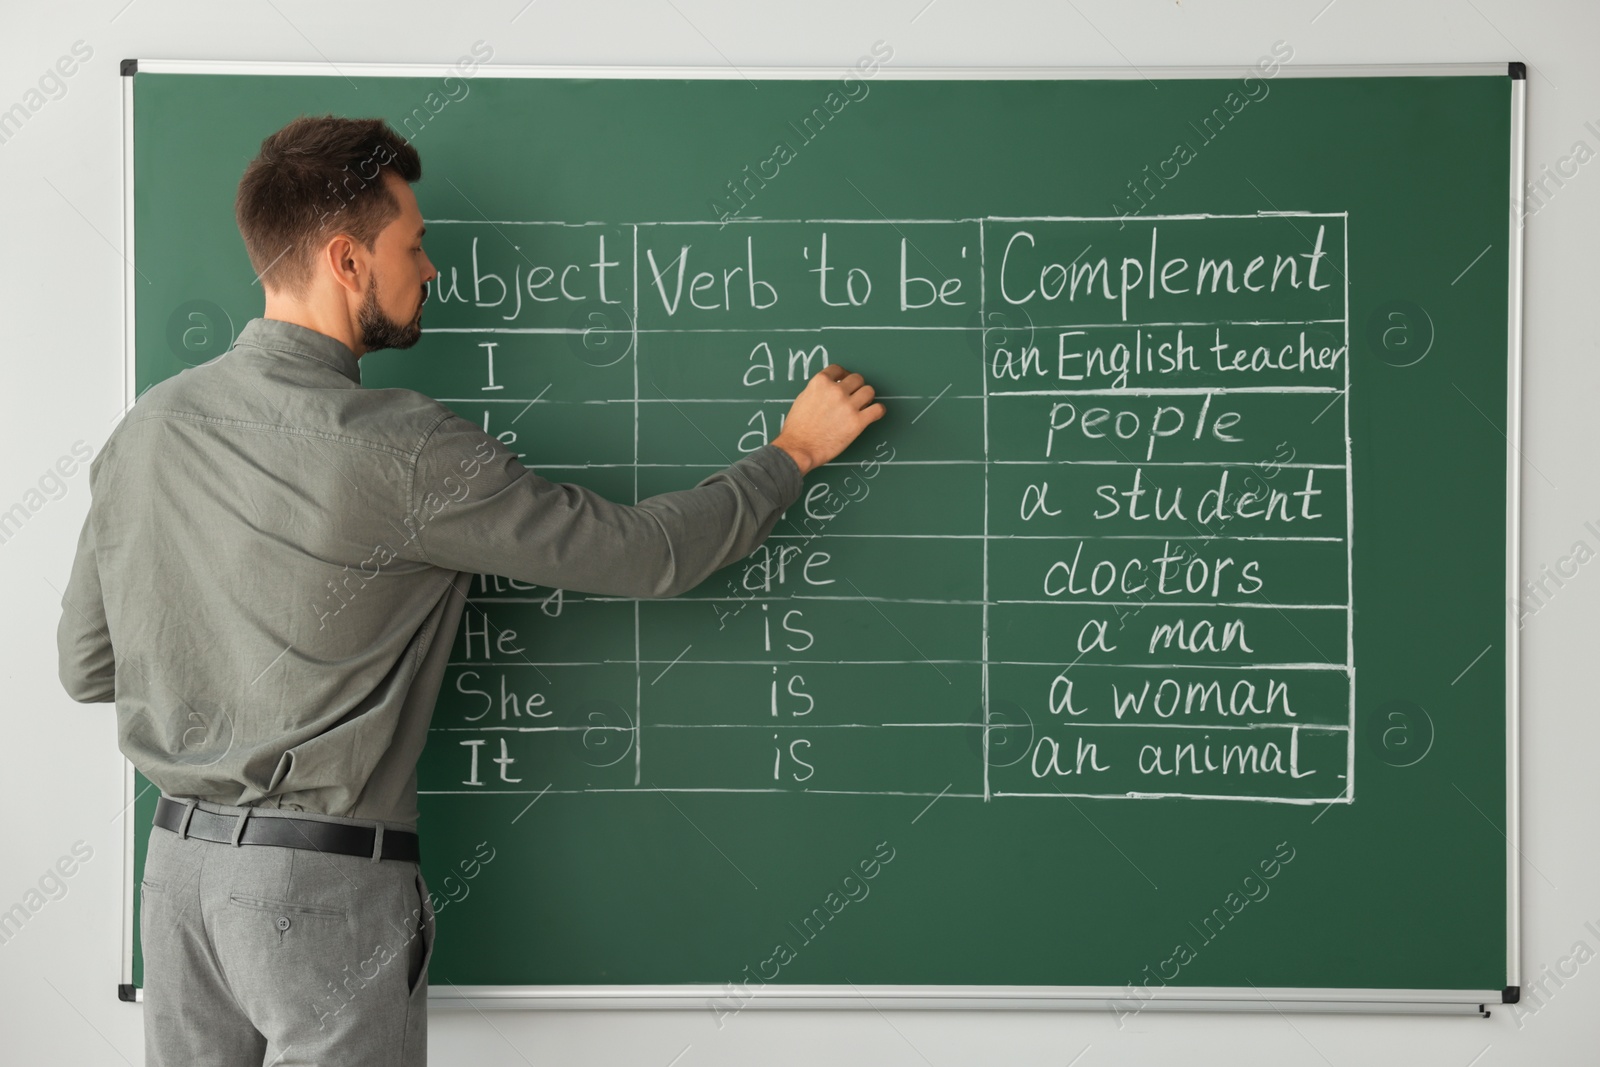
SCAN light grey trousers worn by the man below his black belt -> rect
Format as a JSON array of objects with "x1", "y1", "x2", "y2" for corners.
[{"x1": 139, "y1": 801, "x2": 434, "y2": 1067}]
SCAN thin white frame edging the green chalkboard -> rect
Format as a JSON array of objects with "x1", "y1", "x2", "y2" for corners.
[{"x1": 118, "y1": 59, "x2": 1528, "y2": 1017}]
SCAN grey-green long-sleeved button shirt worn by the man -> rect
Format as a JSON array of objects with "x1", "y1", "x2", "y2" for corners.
[{"x1": 58, "y1": 318, "x2": 802, "y2": 829}]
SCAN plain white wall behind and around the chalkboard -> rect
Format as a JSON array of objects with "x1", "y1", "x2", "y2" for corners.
[{"x1": 0, "y1": 0, "x2": 1600, "y2": 1067}]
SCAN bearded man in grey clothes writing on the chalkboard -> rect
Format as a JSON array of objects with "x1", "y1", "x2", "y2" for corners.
[{"x1": 58, "y1": 117, "x2": 883, "y2": 1067}]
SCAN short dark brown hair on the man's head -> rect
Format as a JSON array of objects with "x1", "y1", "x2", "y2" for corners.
[{"x1": 234, "y1": 115, "x2": 422, "y2": 296}]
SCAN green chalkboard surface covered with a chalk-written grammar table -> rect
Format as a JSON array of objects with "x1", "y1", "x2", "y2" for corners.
[{"x1": 126, "y1": 54, "x2": 1523, "y2": 1009}]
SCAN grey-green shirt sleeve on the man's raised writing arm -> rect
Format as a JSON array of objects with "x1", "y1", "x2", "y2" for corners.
[{"x1": 396, "y1": 416, "x2": 803, "y2": 597}]
